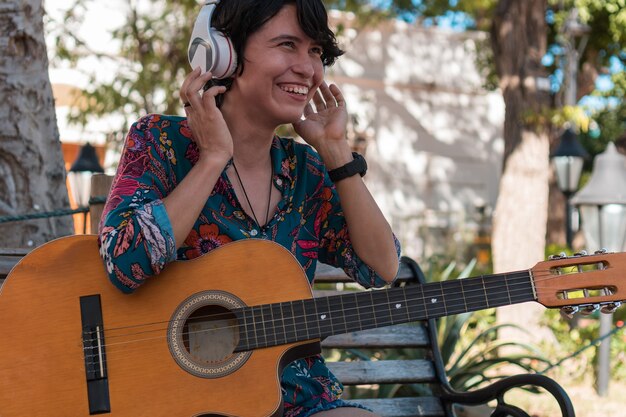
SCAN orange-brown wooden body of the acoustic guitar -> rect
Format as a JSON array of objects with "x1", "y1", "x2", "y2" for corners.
[{"x1": 0, "y1": 236, "x2": 319, "y2": 417}]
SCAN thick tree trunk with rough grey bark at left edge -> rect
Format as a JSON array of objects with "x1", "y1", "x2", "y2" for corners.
[{"x1": 0, "y1": 0, "x2": 72, "y2": 247}]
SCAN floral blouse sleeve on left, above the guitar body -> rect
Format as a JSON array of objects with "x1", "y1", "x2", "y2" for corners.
[{"x1": 98, "y1": 116, "x2": 176, "y2": 293}]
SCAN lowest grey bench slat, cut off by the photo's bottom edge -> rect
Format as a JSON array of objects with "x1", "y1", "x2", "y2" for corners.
[{"x1": 348, "y1": 397, "x2": 445, "y2": 417}]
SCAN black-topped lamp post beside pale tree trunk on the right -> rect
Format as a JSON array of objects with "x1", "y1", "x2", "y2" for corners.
[{"x1": 550, "y1": 129, "x2": 589, "y2": 248}]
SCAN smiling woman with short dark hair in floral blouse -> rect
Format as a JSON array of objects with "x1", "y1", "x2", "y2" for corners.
[{"x1": 100, "y1": 0, "x2": 399, "y2": 417}]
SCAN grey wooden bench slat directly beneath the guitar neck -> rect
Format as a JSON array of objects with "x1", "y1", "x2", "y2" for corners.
[{"x1": 322, "y1": 324, "x2": 430, "y2": 349}]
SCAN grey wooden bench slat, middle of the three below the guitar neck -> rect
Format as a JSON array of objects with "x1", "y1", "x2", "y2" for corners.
[{"x1": 326, "y1": 359, "x2": 435, "y2": 385}]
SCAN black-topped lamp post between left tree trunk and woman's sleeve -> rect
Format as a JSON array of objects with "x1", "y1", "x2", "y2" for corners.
[{"x1": 67, "y1": 143, "x2": 104, "y2": 233}]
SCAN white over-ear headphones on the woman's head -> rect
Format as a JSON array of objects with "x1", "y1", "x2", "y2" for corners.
[{"x1": 187, "y1": 0, "x2": 237, "y2": 79}]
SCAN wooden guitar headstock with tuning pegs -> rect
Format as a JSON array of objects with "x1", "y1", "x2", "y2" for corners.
[{"x1": 530, "y1": 251, "x2": 626, "y2": 317}]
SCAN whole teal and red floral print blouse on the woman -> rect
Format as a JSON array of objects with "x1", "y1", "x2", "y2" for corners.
[{"x1": 99, "y1": 115, "x2": 399, "y2": 417}]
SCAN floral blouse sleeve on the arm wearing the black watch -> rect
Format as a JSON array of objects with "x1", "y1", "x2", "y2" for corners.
[{"x1": 316, "y1": 162, "x2": 400, "y2": 288}]
